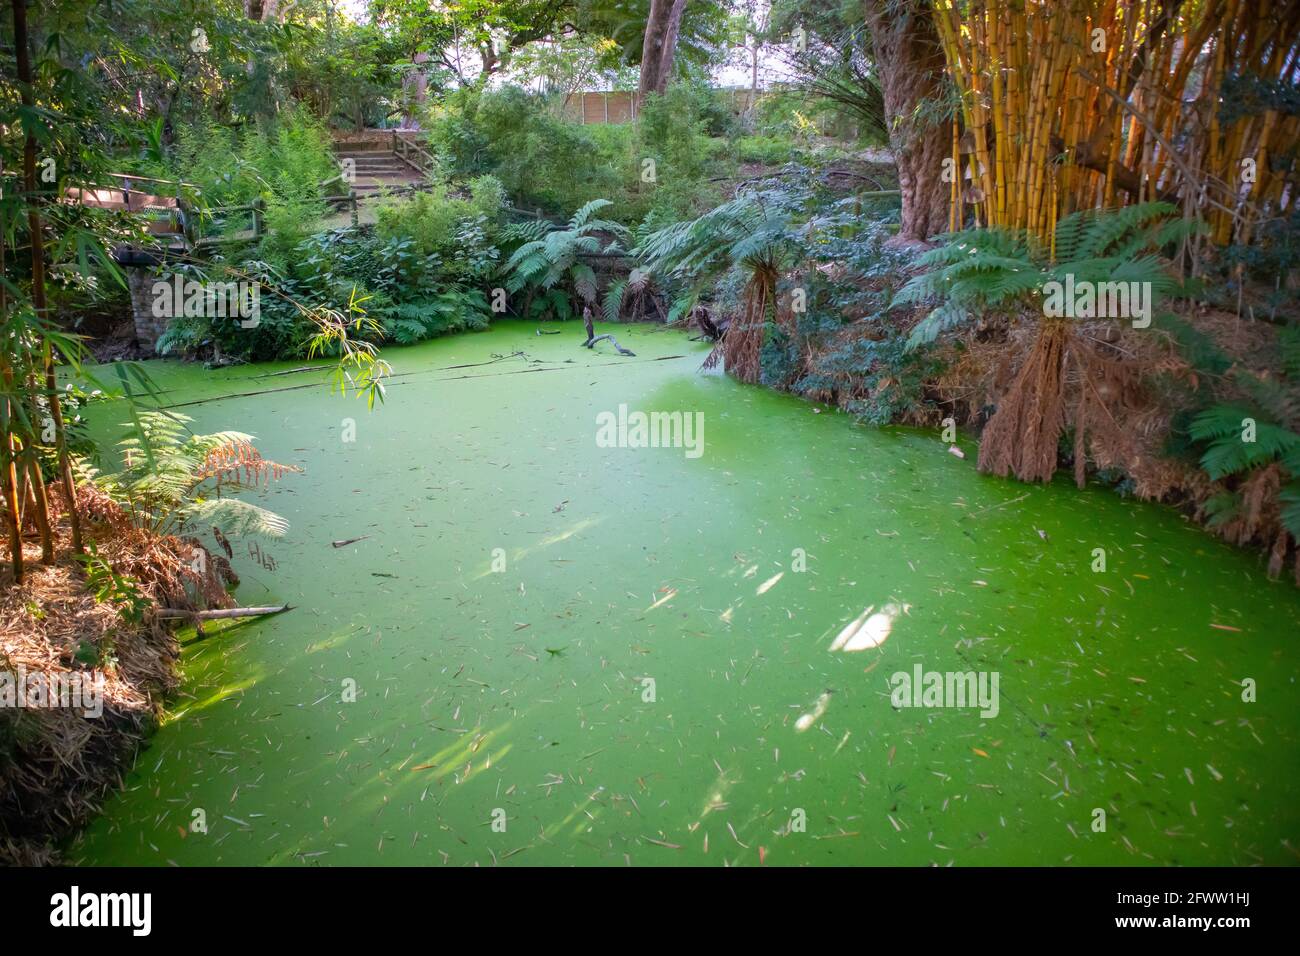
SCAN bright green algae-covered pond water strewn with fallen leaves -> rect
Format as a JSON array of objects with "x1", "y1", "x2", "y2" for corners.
[{"x1": 70, "y1": 324, "x2": 1300, "y2": 866}]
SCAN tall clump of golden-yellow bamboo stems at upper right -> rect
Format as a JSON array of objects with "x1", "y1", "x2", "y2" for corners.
[{"x1": 932, "y1": 0, "x2": 1300, "y2": 254}]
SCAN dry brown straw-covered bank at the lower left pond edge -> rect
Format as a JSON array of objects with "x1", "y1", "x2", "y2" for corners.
[{"x1": 0, "y1": 485, "x2": 233, "y2": 865}]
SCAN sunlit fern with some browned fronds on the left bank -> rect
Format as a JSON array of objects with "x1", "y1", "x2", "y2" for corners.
[{"x1": 99, "y1": 412, "x2": 302, "y2": 537}]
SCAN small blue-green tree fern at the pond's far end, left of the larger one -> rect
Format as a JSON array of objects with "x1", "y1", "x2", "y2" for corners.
[{"x1": 502, "y1": 199, "x2": 628, "y2": 311}]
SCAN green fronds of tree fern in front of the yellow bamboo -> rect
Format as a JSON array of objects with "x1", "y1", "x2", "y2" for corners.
[{"x1": 896, "y1": 203, "x2": 1196, "y2": 349}]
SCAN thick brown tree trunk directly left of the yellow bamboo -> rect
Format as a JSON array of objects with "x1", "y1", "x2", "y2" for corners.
[{"x1": 863, "y1": 0, "x2": 952, "y2": 239}]
